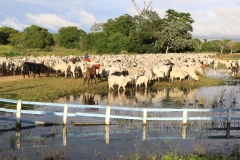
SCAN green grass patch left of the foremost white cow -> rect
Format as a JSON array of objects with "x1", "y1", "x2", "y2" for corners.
[{"x1": 0, "y1": 76, "x2": 108, "y2": 102}]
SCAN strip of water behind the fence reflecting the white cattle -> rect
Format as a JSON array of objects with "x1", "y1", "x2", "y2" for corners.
[{"x1": 56, "y1": 85, "x2": 240, "y2": 109}]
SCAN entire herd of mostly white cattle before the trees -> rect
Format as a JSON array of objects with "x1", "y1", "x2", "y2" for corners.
[{"x1": 0, "y1": 53, "x2": 240, "y2": 90}]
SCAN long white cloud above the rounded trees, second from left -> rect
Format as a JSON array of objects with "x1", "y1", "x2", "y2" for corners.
[{"x1": 26, "y1": 14, "x2": 80, "y2": 31}]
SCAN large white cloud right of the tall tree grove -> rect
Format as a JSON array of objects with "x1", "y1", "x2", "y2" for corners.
[{"x1": 192, "y1": 7, "x2": 240, "y2": 40}]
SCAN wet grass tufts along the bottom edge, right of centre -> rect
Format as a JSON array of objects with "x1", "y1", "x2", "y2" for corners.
[{"x1": 108, "y1": 141, "x2": 230, "y2": 160}]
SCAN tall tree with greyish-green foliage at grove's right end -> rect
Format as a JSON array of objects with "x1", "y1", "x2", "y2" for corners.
[{"x1": 156, "y1": 9, "x2": 194, "y2": 53}]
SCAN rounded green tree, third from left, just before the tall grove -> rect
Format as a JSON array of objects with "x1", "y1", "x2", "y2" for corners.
[{"x1": 58, "y1": 26, "x2": 86, "y2": 48}]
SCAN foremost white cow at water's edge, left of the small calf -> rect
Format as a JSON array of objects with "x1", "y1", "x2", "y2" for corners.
[{"x1": 108, "y1": 75, "x2": 132, "y2": 91}]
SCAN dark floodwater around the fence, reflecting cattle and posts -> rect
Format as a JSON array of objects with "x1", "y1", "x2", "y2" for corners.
[{"x1": 0, "y1": 69, "x2": 240, "y2": 159}]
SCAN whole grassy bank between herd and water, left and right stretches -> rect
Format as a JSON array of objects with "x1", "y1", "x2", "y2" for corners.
[{"x1": 0, "y1": 76, "x2": 224, "y2": 102}]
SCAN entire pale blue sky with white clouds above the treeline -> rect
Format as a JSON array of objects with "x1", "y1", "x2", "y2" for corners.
[{"x1": 0, "y1": 0, "x2": 240, "y2": 41}]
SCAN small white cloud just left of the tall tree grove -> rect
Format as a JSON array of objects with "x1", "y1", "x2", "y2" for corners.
[{"x1": 79, "y1": 11, "x2": 98, "y2": 26}]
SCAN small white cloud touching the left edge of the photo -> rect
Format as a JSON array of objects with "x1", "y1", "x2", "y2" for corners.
[{"x1": 0, "y1": 16, "x2": 27, "y2": 31}]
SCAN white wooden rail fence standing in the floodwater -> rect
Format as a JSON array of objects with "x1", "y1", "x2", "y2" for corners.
[{"x1": 0, "y1": 98, "x2": 240, "y2": 125}]
